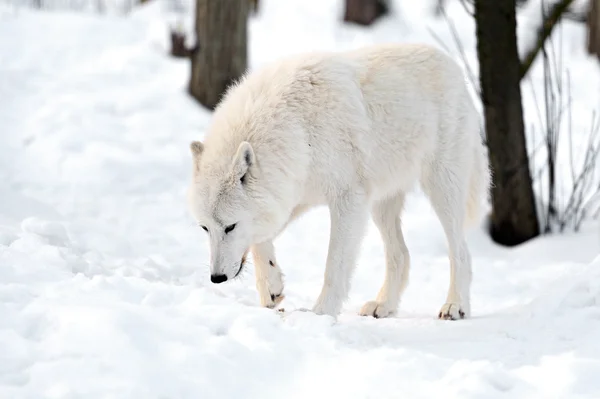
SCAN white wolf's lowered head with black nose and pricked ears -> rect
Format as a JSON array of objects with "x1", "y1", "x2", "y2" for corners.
[{"x1": 188, "y1": 141, "x2": 278, "y2": 284}]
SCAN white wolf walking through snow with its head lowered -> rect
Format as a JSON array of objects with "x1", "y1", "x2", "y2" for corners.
[{"x1": 188, "y1": 44, "x2": 489, "y2": 319}]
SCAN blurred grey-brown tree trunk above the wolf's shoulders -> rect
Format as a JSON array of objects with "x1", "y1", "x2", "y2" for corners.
[{"x1": 189, "y1": 0, "x2": 250, "y2": 110}]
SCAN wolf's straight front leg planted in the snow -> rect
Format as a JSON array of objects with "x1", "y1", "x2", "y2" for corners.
[{"x1": 313, "y1": 192, "x2": 368, "y2": 317}]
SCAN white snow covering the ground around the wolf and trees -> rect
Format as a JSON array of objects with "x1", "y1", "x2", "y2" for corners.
[{"x1": 0, "y1": 0, "x2": 600, "y2": 399}]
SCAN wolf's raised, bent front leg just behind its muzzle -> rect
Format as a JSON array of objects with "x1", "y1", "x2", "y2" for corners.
[{"x1": 250, "y1": 241, "x2": 284, "y2": 308}]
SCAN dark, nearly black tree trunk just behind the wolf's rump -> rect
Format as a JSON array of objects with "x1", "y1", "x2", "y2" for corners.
[{"x1": 475, "y1": 0, "x2": 540, "y2": 245}]
